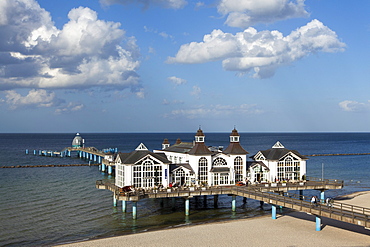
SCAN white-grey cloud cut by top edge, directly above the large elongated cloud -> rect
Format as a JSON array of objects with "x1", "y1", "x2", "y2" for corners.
[{"x1": 217, "y1": 0, "x2": 309, "y2": 28}]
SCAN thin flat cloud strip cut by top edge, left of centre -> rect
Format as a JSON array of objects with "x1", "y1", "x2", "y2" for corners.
[{"x1": 100, "y1": 0, "x2": 188, "y2": 9}]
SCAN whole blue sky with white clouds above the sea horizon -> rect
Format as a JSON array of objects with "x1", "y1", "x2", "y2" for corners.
[{"x1": 0, "y1": 0, "x2": 370, "y2": 133}]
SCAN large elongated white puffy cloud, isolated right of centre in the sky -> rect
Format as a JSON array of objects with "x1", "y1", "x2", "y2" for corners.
[{"x1": 167, "y1": 20, "x2": 345, "y2": 78}]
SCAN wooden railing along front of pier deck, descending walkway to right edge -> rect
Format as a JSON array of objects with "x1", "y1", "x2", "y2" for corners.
[{"x1": 96, "y1": 180, "x2": 370, "y2": 227}]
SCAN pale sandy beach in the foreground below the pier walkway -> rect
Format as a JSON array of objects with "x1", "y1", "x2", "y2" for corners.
[{"x1": 57, "y1": 191, "x2": 370, "y2": 247}]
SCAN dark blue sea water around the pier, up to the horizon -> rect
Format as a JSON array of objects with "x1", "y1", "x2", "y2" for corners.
[{"x1": 0, "y1": 132, "x2": 370, "y2": 246}]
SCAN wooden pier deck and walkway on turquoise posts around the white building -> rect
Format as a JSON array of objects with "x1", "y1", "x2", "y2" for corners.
[{"x1": 96, "y1": 179, "x2": 370, "y2": 231}]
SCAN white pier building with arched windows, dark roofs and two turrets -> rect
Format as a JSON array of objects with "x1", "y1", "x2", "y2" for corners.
[{"x1": 114, "y1": 129, "x2": 307, "y2": 188}]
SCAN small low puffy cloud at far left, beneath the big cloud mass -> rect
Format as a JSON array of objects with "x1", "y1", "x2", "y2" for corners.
[{"x1": 5, "y1": 89, "x2": 61, "y2": 110}]
